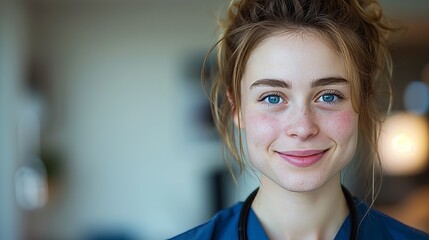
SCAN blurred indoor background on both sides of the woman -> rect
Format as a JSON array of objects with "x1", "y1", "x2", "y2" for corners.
[{"x1": 0, "y1": 0, "x2": 429, "y2": 239}]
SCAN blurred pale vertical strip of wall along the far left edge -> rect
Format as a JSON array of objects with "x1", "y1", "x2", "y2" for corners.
[{"x1": 0, "y1": 1, "x2": 28, "y2": 239}]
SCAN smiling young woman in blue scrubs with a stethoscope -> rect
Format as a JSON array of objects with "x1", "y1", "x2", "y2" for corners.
[{"x1": 173, "y1": 0, "x2": 429, "y2": 240}]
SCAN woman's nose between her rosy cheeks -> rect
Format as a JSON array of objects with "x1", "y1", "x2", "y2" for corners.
[{"x1": 286, "y1": 107, "x2": 319, "y2": 141}]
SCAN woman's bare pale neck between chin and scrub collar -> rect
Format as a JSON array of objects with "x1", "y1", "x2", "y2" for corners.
[{"x1": 252, "y1": 175, "x2": 348, "y2": 239}]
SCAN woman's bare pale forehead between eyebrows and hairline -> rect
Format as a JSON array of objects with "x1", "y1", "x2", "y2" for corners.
[{"x1": 242, "y1": 32, "x2": 347, "y2": 85}]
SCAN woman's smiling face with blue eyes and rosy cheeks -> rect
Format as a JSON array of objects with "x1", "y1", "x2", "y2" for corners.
[{"x1": 234, "y1": 34, "x2": 358, "y2": 191}]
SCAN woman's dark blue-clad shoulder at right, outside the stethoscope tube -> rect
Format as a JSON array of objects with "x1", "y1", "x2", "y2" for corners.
[{"x1": 357, "y1": 203, "x2": 429, "y2": 240}]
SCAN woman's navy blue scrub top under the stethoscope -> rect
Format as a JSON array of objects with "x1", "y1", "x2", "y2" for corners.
[{"x1": 171, "y1": 199, "x2": 429, "y2": 240}]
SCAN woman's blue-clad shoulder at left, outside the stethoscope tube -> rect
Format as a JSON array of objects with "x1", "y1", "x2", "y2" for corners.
[{"x1": 171, "y1": 203, "x2": 243, "y2": 240}]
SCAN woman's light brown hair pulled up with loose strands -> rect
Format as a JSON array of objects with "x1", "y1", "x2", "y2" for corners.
[{"x1": 209, "y1": 0, "x2": 393, "y2": 202}]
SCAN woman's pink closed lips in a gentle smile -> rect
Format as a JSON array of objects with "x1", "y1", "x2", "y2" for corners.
[{"x1": 277, "y1": 149, "x2": 328, "y2": 167}]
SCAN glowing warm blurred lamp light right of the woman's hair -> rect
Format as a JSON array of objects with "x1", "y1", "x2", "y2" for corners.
[{"x1": 379, "y1": 113, "x2": 429, "y2": 175}]
